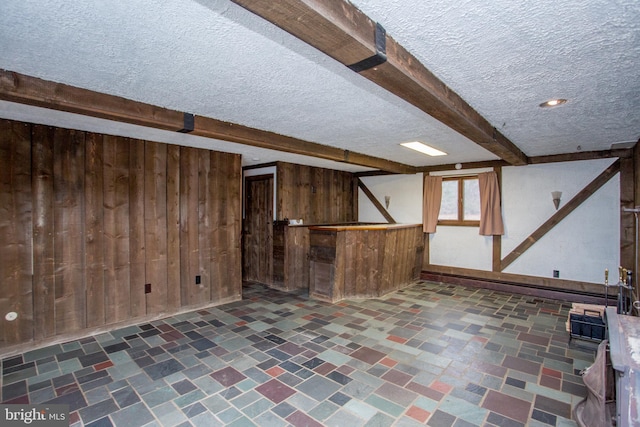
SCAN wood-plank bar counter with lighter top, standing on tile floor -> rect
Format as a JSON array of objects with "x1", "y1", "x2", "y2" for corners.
[{"x1": 309, "y1": 224, "x2": 424, "y2": 302}]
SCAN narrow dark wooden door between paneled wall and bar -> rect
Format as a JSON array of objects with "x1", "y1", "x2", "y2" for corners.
[{"x1": 242, "y1": 175, "x2": 273, "y2": 285}]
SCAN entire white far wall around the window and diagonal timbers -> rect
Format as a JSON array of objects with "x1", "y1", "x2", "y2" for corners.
[{"x1": 358, "y1": 159, "x2": 620, "y2": 283}]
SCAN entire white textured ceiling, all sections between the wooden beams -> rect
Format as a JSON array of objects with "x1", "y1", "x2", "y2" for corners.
[{"x1": 0, "y1": 0, "x2": 640, "y2": 171}]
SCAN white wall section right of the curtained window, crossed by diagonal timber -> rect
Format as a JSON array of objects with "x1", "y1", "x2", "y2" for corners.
[{"x1": 502, "y1": 159, "x2": 620, "y2": 283}]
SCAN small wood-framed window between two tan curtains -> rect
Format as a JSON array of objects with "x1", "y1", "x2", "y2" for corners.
[{"x1": 438, "y1": 176, "x2": 480, "y2": 227}]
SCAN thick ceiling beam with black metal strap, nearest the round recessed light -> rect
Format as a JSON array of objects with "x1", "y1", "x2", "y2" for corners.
[{"x1": 232, "y1": 0, "x2": 527, "y2": 165}]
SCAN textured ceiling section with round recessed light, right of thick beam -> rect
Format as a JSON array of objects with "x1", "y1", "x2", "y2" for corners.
[{"x1": 354, "y1": 0, "x2": 640, "y2": 156}]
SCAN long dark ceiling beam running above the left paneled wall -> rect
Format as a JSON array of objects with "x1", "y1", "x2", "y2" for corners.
[{"x1": 0, "y1": 69, "x2": 416, "y2": 174}]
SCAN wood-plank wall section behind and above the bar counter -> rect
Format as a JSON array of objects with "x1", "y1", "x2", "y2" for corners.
[{"x1": 276, "y1": 162, "x2": 358, "y2": 224}]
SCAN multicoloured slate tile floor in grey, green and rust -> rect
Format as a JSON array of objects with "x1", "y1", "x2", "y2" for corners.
[{"x1": 2, "y1": 282, "x2": 594, "y2": 427}]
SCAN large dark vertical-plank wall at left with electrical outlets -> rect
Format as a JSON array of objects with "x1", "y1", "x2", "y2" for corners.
[{"x1": 0, "y1": 120, "x2": 242, "y2": 349}]
